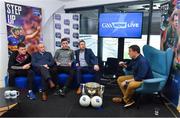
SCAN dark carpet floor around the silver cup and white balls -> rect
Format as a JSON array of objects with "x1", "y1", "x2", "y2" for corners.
[{"x1": 3, "y1": 87, "x2": 179, "y2": 117}]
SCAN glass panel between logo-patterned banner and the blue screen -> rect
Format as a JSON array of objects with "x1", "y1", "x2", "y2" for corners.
[{"x1": 67, "y1": 9, "x2": 98, "y2": 56}]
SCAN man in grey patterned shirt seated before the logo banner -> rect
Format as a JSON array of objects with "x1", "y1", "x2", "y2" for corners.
[{"x1": 52, "y1": 38, "x2": 74, "y2": 96}]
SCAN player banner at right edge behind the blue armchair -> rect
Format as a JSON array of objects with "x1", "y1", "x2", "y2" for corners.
[{"x1": 160, "y1": 0, "x2": 180, "y2": 107}]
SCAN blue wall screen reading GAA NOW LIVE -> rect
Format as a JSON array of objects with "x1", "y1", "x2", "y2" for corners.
[{"x1": 99, "y1": 12, "x2": 143, "y2": 38}]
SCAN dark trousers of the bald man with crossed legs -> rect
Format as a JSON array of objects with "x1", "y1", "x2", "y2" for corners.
[{"x1": 34, "y1": 66, "x2": 51, "y2": 91}]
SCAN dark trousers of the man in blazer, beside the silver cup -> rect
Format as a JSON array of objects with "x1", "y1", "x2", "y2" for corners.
[{"x1": 76, "y1": 67, "x2": 100, "y2": 84}]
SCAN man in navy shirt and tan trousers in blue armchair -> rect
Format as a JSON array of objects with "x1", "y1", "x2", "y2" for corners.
[{"x1": 112, "y1": 45, "x2": 153, "y2": 107}]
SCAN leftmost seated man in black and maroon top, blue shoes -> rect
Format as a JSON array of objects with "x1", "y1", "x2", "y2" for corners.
[{"x1": 8, "y1": 43, "x2": 36, "y2": 99}]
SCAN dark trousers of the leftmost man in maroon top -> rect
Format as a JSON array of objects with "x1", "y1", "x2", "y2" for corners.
[{"x1": 8, "y1": 69, "x2": 34, "y2": 90}]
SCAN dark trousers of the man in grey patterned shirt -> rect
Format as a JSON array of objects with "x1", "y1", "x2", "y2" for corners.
[{"x1": 51, "y1": 66, "x2": 74, "y2": 87}]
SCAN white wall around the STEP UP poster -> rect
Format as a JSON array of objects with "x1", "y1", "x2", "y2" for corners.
[{"x1": 0, "y1": 0, "x2": 64, "y2": 87}]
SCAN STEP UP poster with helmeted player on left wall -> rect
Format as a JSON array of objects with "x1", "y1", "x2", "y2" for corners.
[{"x1": 5, "y1": 2, "x2": 43, "y2": 55}]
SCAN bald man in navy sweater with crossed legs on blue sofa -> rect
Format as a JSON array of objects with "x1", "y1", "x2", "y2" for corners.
[{"x1": 32, "y1": 44, "x2": 55, "y2": 101}]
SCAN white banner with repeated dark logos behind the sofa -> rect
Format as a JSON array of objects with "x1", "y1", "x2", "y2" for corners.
[{"x1": 54, "y1": 13, "x2": 80, "y2": 50}]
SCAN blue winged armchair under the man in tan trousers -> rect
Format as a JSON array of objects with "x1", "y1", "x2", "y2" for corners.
[{"x1": 135, "y1": 45, "x2": 173, "y2": 106}]
